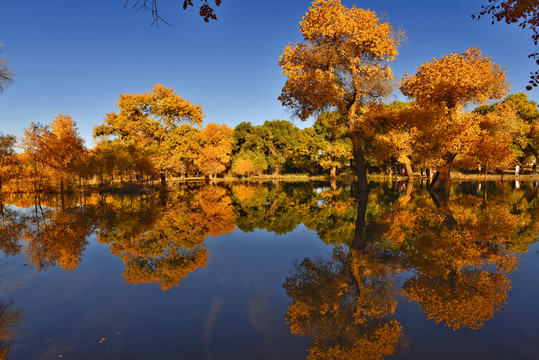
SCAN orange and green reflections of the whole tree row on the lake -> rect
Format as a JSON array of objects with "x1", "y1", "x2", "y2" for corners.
[{"x1": 0, "y1": 182, "x2": 539, "y2": 359}]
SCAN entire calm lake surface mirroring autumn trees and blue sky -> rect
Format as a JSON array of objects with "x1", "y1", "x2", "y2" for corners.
[{"x1": 0, "y1": 182, "x2": 539, "y2": 360}]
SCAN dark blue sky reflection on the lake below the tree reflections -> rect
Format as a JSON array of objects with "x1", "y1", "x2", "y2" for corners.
[{"x1": 0, "y1": 183, "x2": 539, "y2": 359}]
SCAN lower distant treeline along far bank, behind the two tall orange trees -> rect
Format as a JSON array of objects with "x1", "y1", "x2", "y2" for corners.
[{"x1": 0, "y1": 84, "x2": 539, "y2": 191}]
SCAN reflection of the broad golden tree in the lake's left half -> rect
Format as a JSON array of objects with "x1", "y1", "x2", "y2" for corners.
[{"x1": 97, "y1": 186, "x2": 235, "y2": 290}]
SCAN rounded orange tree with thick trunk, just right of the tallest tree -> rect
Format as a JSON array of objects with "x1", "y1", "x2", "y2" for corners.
[{"x1": 400, "y1": 47, "x2": 509, "y2": 190}]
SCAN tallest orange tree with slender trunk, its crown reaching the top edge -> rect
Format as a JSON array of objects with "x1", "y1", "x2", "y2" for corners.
[{"x1": 279, "y1": 0, "x2": 403, "y2": 190}]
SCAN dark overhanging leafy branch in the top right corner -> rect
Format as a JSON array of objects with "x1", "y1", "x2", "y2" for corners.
[{"x1": 472, "y1": 0, "x2": 539, "y2": 91}]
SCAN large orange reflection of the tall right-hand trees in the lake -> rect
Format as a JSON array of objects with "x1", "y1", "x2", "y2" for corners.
[{"x1": 283, "y1": 183, "x2": 537, "y2": 359}]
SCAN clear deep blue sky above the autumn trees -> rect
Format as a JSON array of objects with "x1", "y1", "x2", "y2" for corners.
[{"x1": 0, "y1": 0, "x2": 539, "y2": 147}]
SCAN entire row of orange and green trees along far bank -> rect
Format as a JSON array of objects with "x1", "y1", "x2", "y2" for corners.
[{"x1": 0, "y1": 0, "x2": 539, "y2": 194}]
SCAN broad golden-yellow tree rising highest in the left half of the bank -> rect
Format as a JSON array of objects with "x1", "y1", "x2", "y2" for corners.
[{"x1": 94, "y1": 84, "x2": 204, "y2": 185}]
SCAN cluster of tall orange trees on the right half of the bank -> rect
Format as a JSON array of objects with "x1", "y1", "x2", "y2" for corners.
[{"x1": 279, "y1": 0, "x2": 537, "y2": 190}]
